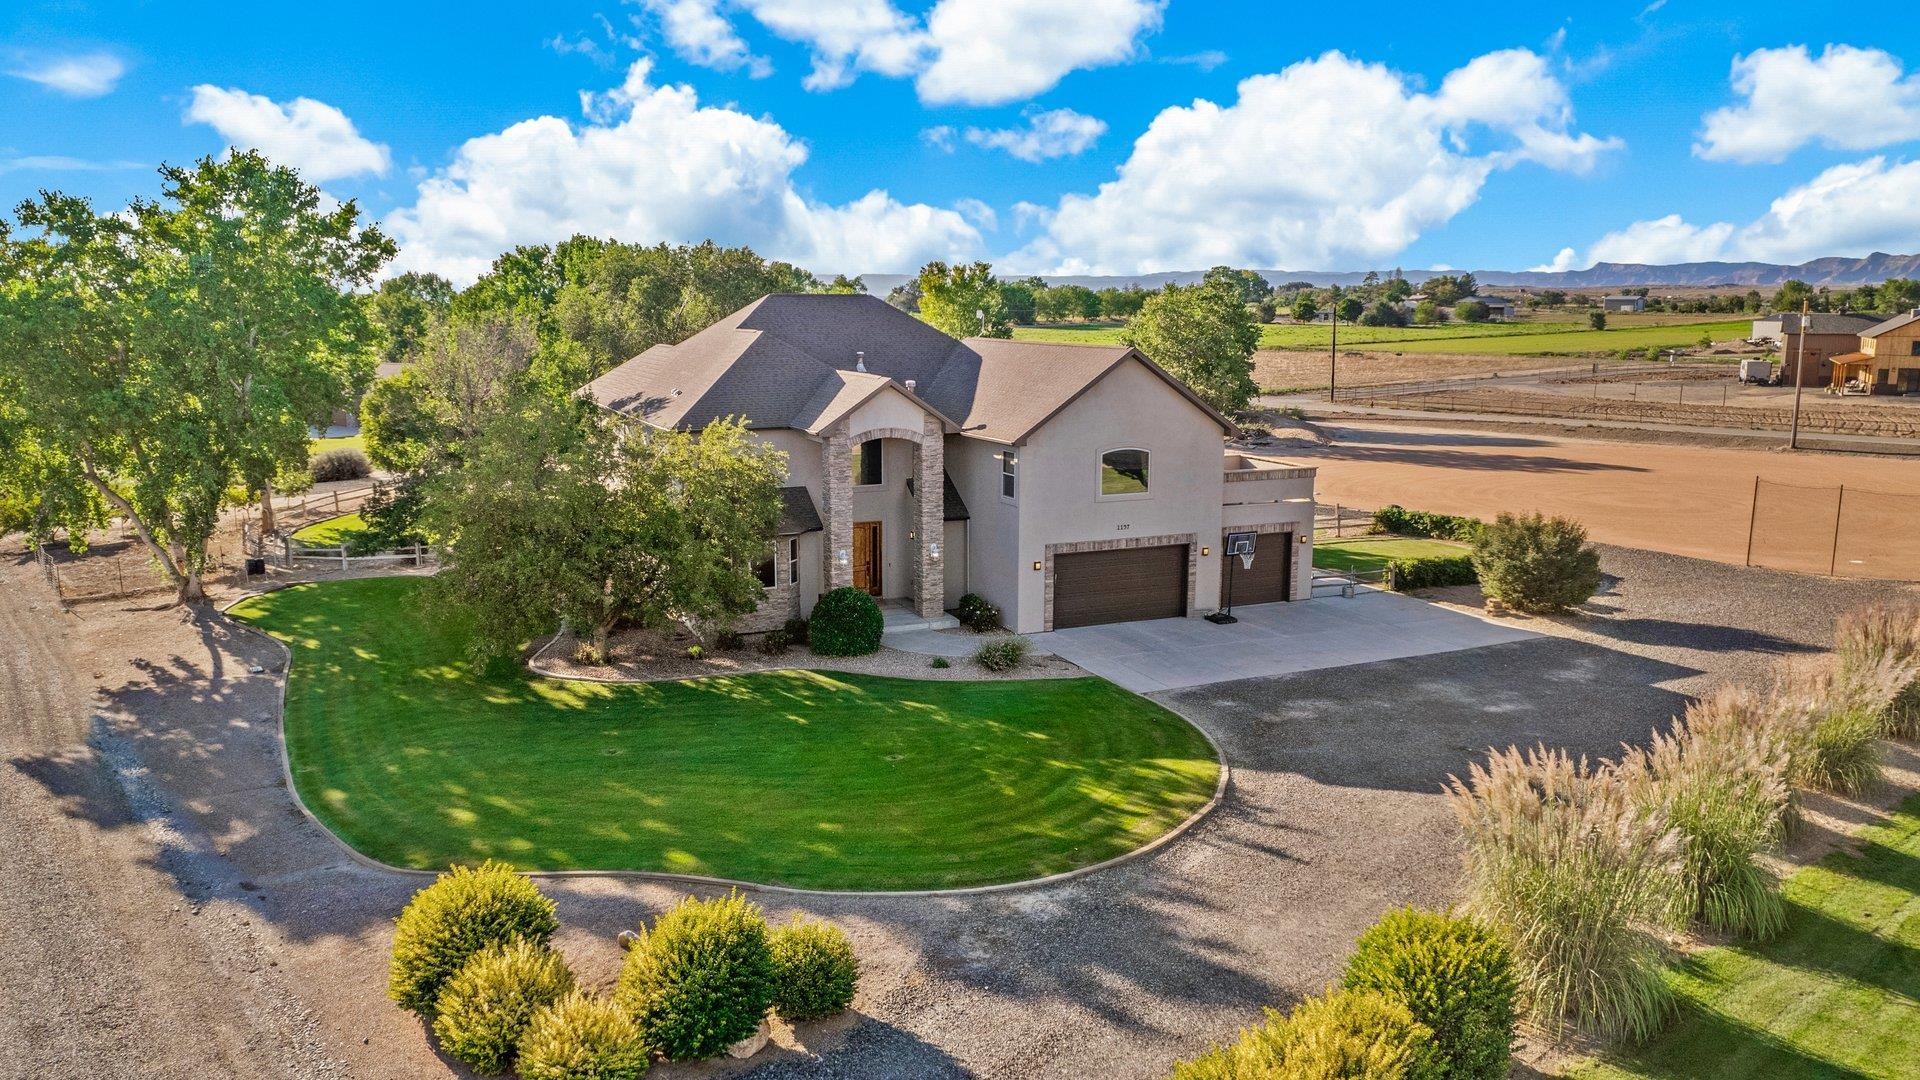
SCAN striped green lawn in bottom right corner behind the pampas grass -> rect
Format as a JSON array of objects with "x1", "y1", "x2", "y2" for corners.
[{"x1": 1572, "y1": 798, "x2": 1920, "y2": 1080}]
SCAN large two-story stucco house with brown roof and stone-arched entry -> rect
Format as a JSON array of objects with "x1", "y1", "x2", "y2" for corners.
[{"x1": 586, "y1": 294, "x2": 1313, "y2": 632}]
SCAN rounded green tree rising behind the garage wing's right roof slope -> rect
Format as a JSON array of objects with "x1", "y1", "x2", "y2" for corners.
[{"x1": 1121, "y1": 276, "x2": 1260, "y2": 413}]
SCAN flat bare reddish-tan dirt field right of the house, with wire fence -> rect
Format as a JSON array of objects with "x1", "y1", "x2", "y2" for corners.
[{"x1": 1286, "y1": 423, "x2": 1920, "y2": 578}]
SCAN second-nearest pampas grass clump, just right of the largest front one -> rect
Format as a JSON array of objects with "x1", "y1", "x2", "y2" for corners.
[{"x1": 1619, "y1": 688, "x2": 1793, "y2": 940}]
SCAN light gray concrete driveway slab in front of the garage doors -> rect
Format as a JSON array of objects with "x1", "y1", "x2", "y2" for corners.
[{"x1": 1033, "y1": 590, "x2": 1536, "y2": 694}]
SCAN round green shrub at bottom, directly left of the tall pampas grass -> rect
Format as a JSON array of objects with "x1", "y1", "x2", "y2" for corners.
[{"x1": 1344, "y1": 907, "x2": 1519, "y2": 1080}]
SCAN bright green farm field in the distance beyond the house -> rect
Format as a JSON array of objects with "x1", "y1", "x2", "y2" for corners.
[{"x1": 1014, "y1": 321, "x2": 1753, "y2": 356}]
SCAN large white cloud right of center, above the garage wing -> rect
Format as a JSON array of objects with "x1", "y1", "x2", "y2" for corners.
[{"x1": 1008, "y1": 50, "x2": 1619, "y2": 273}]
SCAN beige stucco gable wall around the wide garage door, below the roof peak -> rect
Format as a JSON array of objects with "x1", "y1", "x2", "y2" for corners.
[{"x1": 1013, "y1": 359, "x2": 1223, "y2": 634}]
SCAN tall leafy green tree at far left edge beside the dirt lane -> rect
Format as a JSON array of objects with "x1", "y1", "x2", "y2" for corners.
[{"x1": 0, "y1": 152, "x2": 394, "y2": 601}]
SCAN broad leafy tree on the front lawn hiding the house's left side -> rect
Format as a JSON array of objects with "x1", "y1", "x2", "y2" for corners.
[{"x1": 424, "y1": 386, "x2": 787, "y2": 661}]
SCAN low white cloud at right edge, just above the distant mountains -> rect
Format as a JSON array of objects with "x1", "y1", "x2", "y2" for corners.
[{"x1": 1588, "y1": 158, "x2": 1920, "y2": 263}]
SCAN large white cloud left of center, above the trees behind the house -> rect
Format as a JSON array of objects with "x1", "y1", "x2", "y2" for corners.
[{"x1": 386, "y1": 60, "x2": 981, "y2": 282}]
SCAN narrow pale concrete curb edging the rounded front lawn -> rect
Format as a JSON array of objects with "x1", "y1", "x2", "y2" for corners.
[{"x1": 217, "y1": 582, "x2": 1233, "y2": 899}]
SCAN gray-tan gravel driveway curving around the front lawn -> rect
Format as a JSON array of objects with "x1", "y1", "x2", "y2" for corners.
[{"x1": 0, "y1": 550, "x2": 1904, "y2": 1080}]
